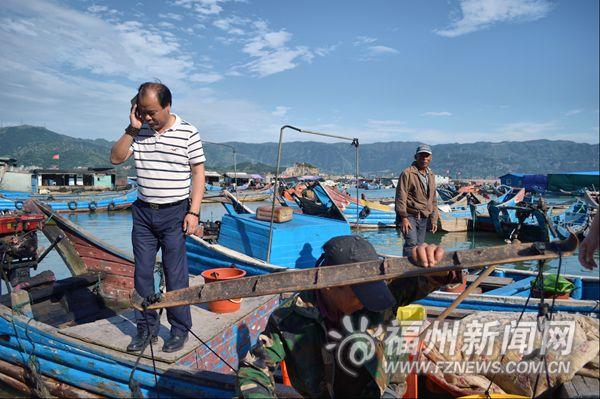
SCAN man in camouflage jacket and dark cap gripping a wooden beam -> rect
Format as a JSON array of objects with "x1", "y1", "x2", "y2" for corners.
[{"x1": 238, "y1": 236, "x2": 456, "y2": 398}]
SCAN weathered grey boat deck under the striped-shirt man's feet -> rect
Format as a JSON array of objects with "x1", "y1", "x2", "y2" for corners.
[{"x1": 59, "y1": 295, "x2": 278, "y2": 369}]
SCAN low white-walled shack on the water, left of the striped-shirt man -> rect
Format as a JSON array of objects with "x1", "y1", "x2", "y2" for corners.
[{"x1": 32, "y1": 168, "x2": 116, "y2": 192}]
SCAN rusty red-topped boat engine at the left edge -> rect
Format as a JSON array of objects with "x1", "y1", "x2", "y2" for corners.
[{"x1": 0, "y1": 211, "x2": 44, "y2": 287}]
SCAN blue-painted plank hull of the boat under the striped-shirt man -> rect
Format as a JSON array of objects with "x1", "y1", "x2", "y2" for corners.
[{"x1": 0, "y1": 300, "x2": 278, "y2": 398}]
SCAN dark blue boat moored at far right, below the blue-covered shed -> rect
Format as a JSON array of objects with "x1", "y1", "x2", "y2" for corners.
[{"x1": 490, "y1": 200, "x2": 590, "y2": 242}]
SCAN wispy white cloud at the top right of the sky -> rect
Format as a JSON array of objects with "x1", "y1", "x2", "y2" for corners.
[{"x1": 435, "y1": 0, "x2": 552, "y2": 37}]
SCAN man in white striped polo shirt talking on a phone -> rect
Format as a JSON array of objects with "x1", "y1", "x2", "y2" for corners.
[{"x1": 110, "y1": 82, "x2": 205, "y2": 352}]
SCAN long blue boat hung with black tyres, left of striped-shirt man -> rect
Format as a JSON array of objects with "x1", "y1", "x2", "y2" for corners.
[{"x1": 0, "y1": 187, "x2": 137, "y2": 213}]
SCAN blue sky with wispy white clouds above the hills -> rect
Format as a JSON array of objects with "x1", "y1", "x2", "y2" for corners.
[{"x1": 0, "y1": 0, "x2": 599, "y2": 144}]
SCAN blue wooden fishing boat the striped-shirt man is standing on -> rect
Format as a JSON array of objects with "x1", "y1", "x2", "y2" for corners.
[{"x1": 0, "y1": 202, "x2": 295, "y2": 398}]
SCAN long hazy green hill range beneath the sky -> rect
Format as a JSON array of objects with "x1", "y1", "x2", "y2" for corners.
[{"x1": 0, "y1": 125, "x2": 599, "y2": 178}]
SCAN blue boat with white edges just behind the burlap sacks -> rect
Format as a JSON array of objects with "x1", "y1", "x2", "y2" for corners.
[{"x1": 417, "y1": 268, "x2": 600, "y2": 318}]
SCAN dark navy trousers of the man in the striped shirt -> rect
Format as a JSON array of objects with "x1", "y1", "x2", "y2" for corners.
[{"x1": 131, "y1": 200, "x2": 192, "y2": 335}]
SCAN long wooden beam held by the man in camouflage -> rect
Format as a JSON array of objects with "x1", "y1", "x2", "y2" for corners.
[{"x1": 131, "y1": 235, "x2": 578, "y2": 310}]
